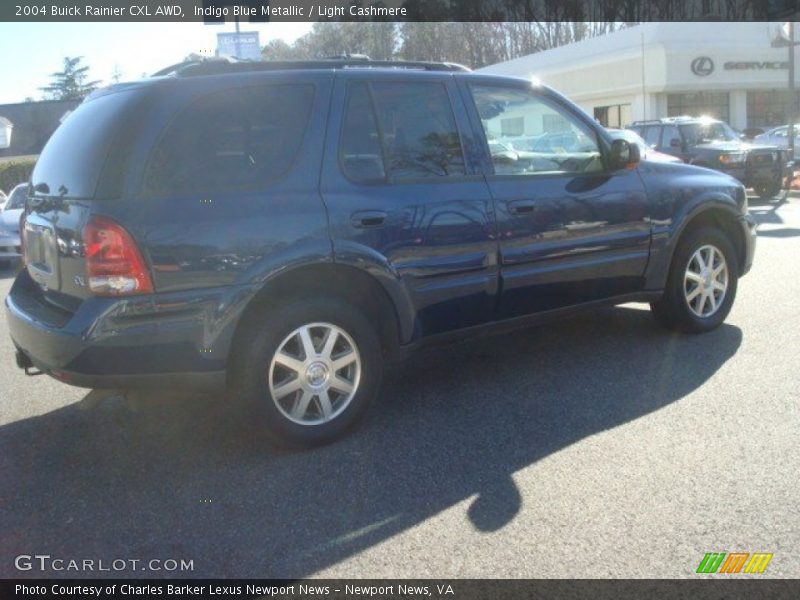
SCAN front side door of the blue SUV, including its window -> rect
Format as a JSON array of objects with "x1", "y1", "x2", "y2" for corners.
[{"x1": 460, "y1": 80, "x2": 650, "y2": 319}]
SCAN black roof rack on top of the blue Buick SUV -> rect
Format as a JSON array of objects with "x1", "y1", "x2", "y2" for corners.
[{"x1": 153, "y1": 54, "x2": 470, "y2": 77}]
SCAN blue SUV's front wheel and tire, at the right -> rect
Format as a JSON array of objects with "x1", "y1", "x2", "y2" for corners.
[{"x1": 650, "y1": 227, "x2": 739, "y2": 333}]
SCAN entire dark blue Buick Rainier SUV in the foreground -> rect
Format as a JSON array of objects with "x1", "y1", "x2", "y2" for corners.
[{"x1": 5, "y1": 59, "x2": 755, "y2": 446}]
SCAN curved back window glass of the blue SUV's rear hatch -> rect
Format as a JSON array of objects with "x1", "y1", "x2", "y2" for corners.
[{"x1": 31, "y1": 90, "x2": 139, "y2": 198}]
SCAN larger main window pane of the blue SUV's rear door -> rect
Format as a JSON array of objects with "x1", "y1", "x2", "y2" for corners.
[{"x1": 372, "y1": 81, "x2": 465, "y2": 179}]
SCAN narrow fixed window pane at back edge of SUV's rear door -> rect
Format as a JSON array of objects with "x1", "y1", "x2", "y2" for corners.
[{"x1": 339, "y1": 83, "x2": 386, "y2": 181}]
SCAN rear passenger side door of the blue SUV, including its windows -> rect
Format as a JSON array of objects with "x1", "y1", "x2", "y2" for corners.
[{"x1": 321, "y1": 70, "x2": 498, "y2": 341}]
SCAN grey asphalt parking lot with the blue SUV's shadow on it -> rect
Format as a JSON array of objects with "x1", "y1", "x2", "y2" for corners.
[{"x1": 0, "y1": 198, "x2": 800, "y2": 578}]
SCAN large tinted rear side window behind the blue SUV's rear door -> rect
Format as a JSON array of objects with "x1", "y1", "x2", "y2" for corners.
[{"x1": 146, "y1": 85, "x2": 314, "y2": 195}]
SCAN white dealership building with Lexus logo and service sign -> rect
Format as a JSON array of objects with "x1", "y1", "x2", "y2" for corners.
[{"x1": 481, "y1": 22, "x2": 800, "y2": 129}]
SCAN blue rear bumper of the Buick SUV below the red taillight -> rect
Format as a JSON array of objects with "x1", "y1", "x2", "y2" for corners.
[{"x1": 5, "y1": 271, "x2": 244, "y2": 390}]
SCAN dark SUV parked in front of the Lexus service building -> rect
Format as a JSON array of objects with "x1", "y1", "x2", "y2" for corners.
[{"x1": 628, "y1": 117, "x2": 792, "y2": 199}]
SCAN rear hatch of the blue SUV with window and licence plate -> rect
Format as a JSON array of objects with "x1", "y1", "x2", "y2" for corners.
[{"x1": 20, "y1": 89, "x2": 147, "y2": 311}]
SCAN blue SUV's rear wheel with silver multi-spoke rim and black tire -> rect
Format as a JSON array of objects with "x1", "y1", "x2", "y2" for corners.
[{"x1": 232, "y1": 299, "x2": 383, "y2": 448}]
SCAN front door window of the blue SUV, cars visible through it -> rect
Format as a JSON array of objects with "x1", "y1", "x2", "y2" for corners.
[{"x1": 471, "y1": 85, "x2": 603, "y2": 175}]
